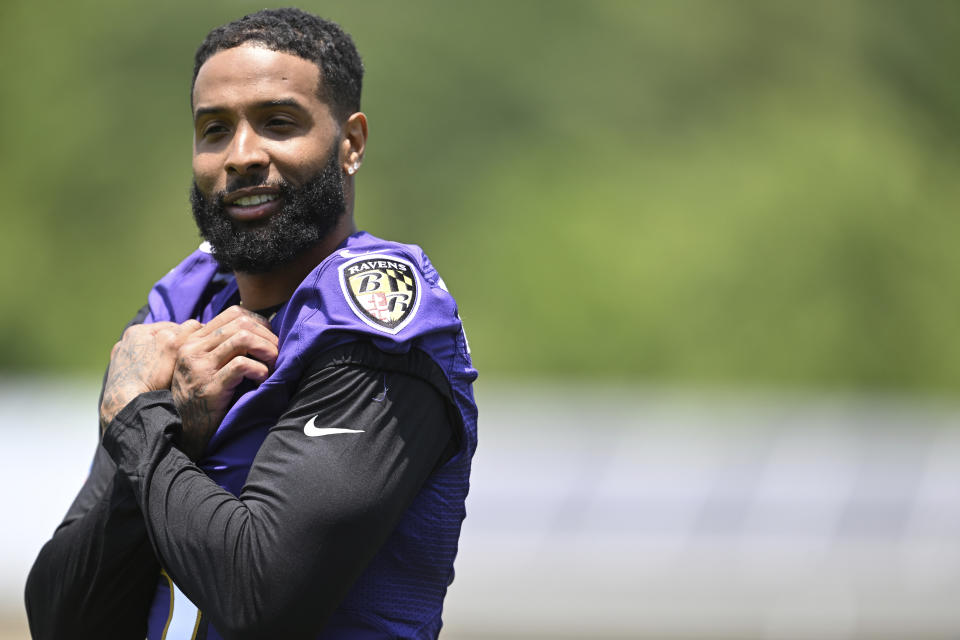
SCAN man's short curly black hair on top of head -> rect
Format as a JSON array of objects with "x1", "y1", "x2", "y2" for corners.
[{"x1": 190, "y1": 8, "x2": 363, "y2": 120}]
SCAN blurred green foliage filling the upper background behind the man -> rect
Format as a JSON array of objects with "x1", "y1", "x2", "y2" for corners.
[{"x1": 0, "y1": 0, "x2": 960, "y2": 394}]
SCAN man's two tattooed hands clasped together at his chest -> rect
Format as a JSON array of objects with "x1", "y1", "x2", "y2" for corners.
[{"x1": 100, "y1": 306, "x2": 279, "y2": 460}]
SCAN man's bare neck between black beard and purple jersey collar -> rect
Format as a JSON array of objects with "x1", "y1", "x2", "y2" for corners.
[{"x1": 234, "y1": 212, "x2": 357, "y2": 311}]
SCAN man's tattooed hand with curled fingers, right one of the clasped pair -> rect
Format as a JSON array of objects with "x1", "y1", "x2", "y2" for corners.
[{"x1": 171, "y1": 307, "x2": 279, "y2": 460}]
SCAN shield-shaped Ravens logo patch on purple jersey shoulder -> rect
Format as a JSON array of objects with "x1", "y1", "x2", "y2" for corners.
[{"x1": 340, "y1": 253, "x2": 420, "y2": 334}]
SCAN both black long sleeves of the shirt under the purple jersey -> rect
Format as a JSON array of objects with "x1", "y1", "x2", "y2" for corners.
[{"x1": 26, "y1": 342, "x2": 457, "y2": 639}]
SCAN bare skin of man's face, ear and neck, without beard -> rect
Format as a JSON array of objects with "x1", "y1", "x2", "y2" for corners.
[{"x1": 193, "y1": 44, "x2": 367, "y2": 309}]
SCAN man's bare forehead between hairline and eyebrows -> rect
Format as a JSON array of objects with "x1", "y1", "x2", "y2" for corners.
[{"x1": 193, "y1": 44, "x2": 320, "y2": 110}]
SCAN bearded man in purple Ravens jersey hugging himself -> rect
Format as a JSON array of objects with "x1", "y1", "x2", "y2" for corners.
[{"x1": 26, "y1": 9, "x2": 476, "y2": 640}]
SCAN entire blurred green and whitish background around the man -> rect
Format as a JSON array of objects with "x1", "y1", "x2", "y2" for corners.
[{"x1": 0, "y1": 0, "x2": 960, "y2": 638}]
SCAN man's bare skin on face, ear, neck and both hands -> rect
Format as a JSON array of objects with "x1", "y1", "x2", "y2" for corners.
[{"x1": 100, "y1": 44, "x2": 367, "y2": 460}]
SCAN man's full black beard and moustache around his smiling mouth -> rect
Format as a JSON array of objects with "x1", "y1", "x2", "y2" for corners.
[{"x1": 190, "y1": 146, "x2": 346, "y2": 273}]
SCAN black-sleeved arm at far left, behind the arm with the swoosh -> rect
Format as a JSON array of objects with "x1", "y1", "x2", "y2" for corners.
[{"x1": 25, "y1": 307, "x2": 160, "y2": 639}]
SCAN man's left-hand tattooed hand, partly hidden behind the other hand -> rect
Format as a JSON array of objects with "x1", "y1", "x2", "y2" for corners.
[{"x1": 100, "y1": 320, "x2": 201, "y2": 434}]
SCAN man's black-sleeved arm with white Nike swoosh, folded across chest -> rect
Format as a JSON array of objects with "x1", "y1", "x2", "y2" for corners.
[{"x1": 104, "y1": 343, "x2": 452, "y2": 638}]
